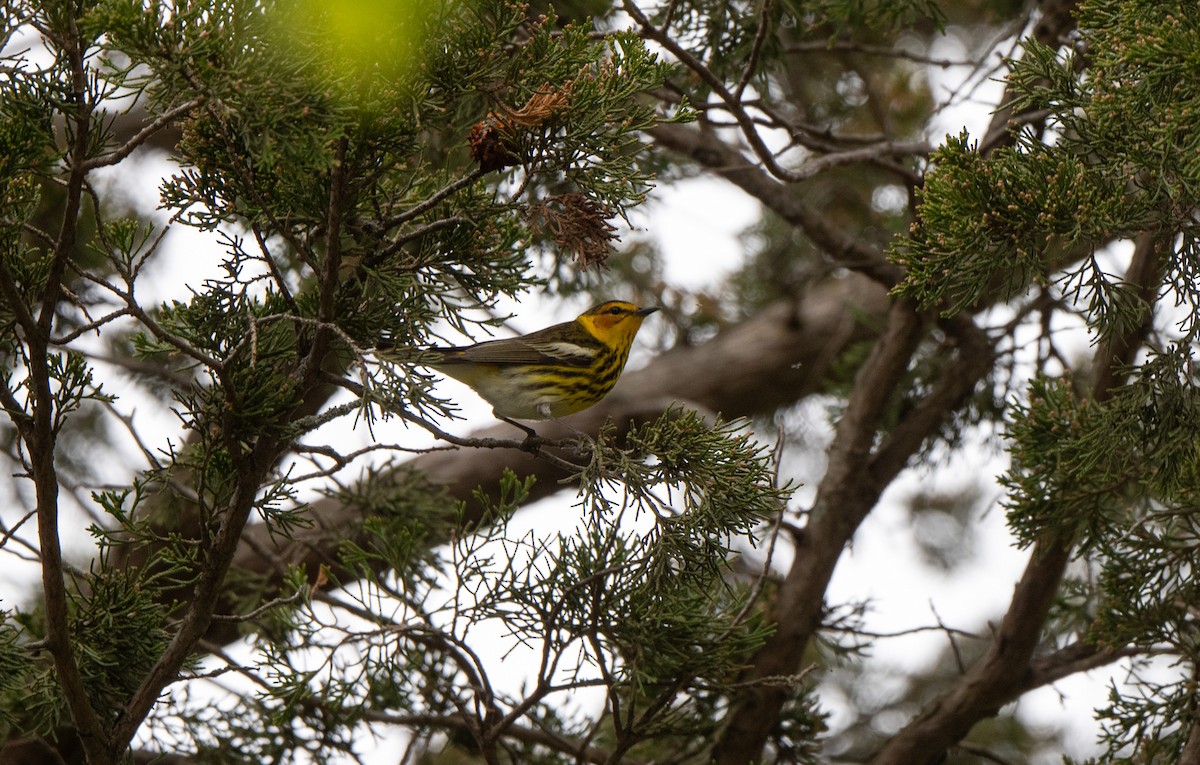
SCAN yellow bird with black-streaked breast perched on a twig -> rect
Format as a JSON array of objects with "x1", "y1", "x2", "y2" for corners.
[{"x1": 422, "y1": 300, "x2": 658, "y2": 438}]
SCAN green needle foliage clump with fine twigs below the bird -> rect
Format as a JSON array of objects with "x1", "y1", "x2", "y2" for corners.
[{"x1": 237, "y1": 411, "x2": 786, "y2": 763}]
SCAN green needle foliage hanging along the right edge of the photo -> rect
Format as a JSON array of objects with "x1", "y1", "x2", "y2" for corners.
[{"x1": 894, "y1": 0, "x2": 1200, "y2": 763}]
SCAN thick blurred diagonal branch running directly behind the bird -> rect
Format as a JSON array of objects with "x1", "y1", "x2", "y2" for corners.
[{"x1": 208, "y1": 276, "x2": 887, "y2": 643}]
